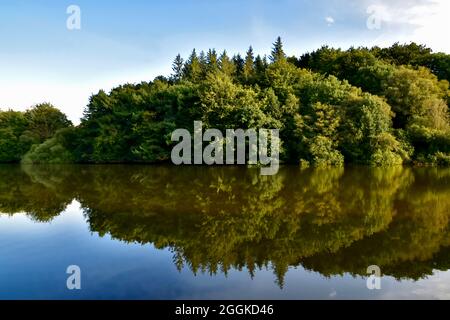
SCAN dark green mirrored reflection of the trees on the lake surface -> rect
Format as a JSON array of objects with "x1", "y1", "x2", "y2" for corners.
[{"x1": 0, "y1": 166, "x2": 450, "y2": 286}]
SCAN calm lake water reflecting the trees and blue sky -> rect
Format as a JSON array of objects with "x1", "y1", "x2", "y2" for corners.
[{"x1": 0, "y1": 166, "x2": 450, "y2": 299}]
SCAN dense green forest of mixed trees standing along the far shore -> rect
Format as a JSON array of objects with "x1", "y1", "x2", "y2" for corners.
[{"x1": 0, "y1": 38, "x2": 450, "y2": 166}]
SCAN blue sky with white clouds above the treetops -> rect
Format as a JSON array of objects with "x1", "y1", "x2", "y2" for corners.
[{"x1": 0, "y1": 0, "x2": 450, "y2": 122}]
